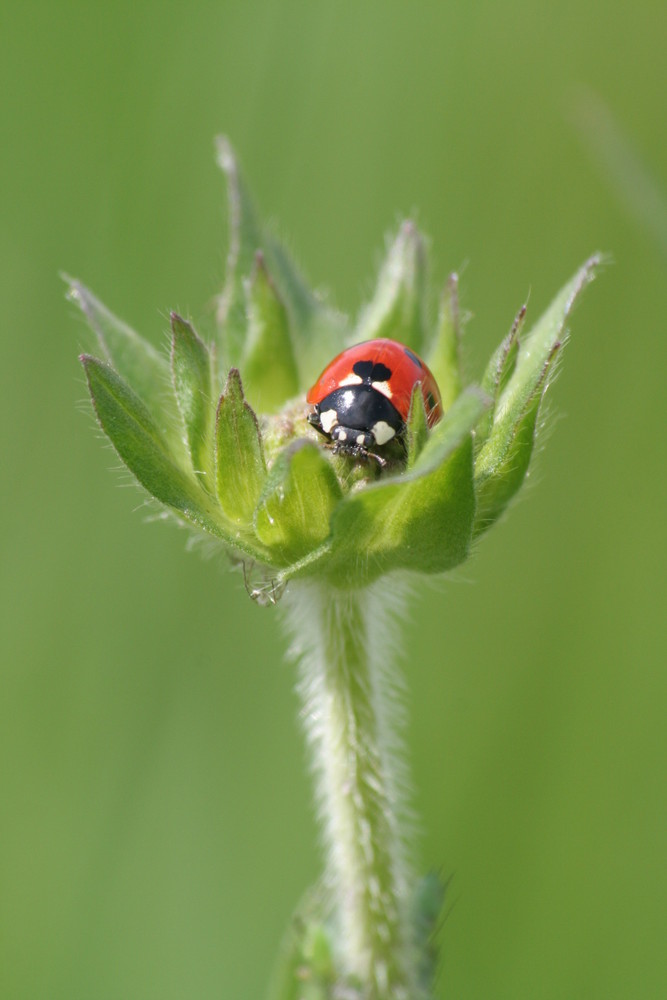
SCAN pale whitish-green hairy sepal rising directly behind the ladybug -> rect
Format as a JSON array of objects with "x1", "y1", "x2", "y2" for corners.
[{"x1": 355, "y1": 220, "x2": 428, "y2": 354}]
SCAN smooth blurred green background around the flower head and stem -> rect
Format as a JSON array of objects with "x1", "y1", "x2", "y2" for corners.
[{"x1": 0, "y1": 0, "x2": 667, "y2": 1000}]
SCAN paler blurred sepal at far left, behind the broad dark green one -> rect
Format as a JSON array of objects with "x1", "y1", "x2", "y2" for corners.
[{"x1": 63, "y1": 275, "x2": 185, "y2": 455}]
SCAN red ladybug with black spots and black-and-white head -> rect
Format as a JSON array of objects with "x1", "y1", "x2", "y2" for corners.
[{"x1": 306, "y1": 338, "x2": 442, "y2": 465}]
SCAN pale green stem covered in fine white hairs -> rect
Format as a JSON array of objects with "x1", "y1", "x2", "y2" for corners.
[{"x1": 285, "y1": 581, "x2": 416, "y2": 1000}]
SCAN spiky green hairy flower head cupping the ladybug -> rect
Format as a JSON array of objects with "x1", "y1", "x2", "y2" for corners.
[{"x1": 69, "y1": 140, "x2": 599, "y2": 602}]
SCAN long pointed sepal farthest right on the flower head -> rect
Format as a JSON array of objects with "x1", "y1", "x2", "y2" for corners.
[{"x1": 475, "y1": 256, "x2": 600, "y2": 534}]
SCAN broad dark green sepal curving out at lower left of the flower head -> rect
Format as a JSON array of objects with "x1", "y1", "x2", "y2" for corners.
[{"x1": 81, "y1": 354, "x2": 230, "y2": 541}]
